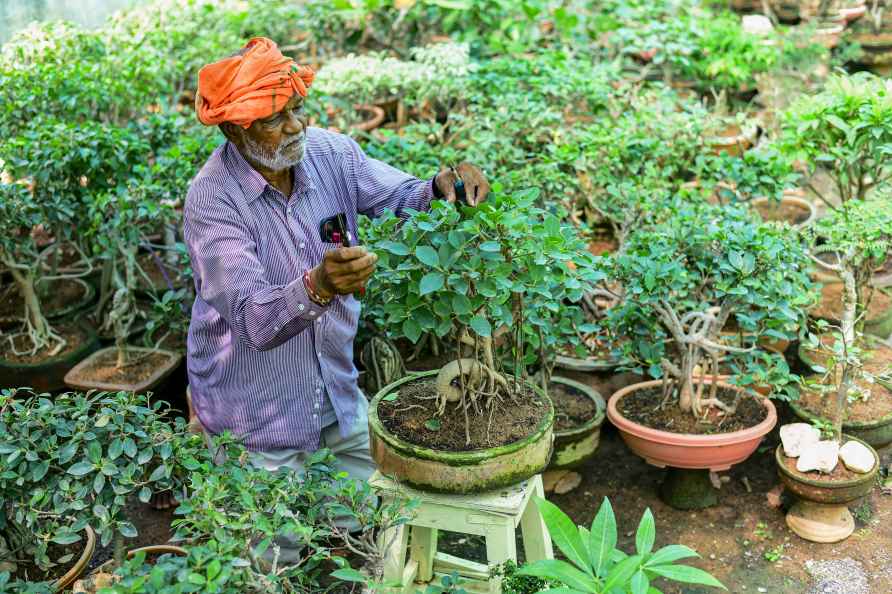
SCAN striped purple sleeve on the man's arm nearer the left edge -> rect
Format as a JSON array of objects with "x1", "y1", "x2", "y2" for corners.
[{"x1": 183, "y1": 185, "x2": 327, "y2": 351}]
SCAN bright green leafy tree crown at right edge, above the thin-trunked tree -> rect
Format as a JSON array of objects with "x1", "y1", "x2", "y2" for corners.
[{"x1": 783, "y1": 72, "x2": 892, "y2": 208}]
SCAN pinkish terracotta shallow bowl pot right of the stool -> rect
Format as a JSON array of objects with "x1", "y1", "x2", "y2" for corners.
[{"x1": 607, "y1": 378, "x2": 777, "y2": 471}]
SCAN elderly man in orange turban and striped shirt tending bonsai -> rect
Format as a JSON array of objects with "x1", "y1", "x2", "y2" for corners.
[{"x1": 184, "y1": 38, "x2": 488, "y2": 492}]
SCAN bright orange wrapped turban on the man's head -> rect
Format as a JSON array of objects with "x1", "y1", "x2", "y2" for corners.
[{"x1": 195, "y1": 37, "x2": 315, "y2": 128}]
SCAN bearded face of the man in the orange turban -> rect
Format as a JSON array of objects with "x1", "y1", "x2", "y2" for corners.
[{"x1": 234, "y1": 95, "x2": 307, "y2": 171}]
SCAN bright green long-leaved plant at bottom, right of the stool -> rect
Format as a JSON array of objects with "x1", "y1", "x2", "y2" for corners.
[{"x1": 516, "y1": 497, "x2": 727, "y2": 594}]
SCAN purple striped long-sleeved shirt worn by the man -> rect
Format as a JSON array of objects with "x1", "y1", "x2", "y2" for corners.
[{"x1": 184, "y1": 128, "x2": 432, "y2": 451}]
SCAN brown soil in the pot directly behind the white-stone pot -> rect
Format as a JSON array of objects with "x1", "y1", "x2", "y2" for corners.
[{"x1": 799, "y1": 334, "x2": 892, "y2": 423}]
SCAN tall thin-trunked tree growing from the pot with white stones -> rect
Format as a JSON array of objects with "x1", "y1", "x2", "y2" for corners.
[{"x1": 810, "y1": 196, "x2": 892, "y2": 439}]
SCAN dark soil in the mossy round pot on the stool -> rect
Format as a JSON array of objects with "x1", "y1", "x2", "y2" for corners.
[{"x1": 378, "y1": 379, "x2": 548, "y2": 452}]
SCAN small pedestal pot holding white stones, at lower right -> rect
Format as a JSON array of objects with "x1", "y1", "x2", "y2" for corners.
[{"x1": 774, "y1": 435, "x2": 880, "y2": 543}]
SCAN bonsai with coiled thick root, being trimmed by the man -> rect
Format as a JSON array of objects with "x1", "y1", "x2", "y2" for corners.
[{"x1": 360, "y1": 186, "x2": 602, "y2": 440}]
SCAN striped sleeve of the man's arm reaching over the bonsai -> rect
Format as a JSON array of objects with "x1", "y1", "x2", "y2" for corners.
[{"x1": 347, "y1": 139, "x2": 433, "y2": 218}]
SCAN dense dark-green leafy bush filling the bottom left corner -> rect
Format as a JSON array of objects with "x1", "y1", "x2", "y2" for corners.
[{"x1": 0, "y1": 389, "x2": 207, "y2": 570}]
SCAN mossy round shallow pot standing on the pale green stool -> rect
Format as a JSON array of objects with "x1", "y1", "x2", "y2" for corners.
[{"x1": 369, "y1": 370, "x2": 554, "y2": 494}]
